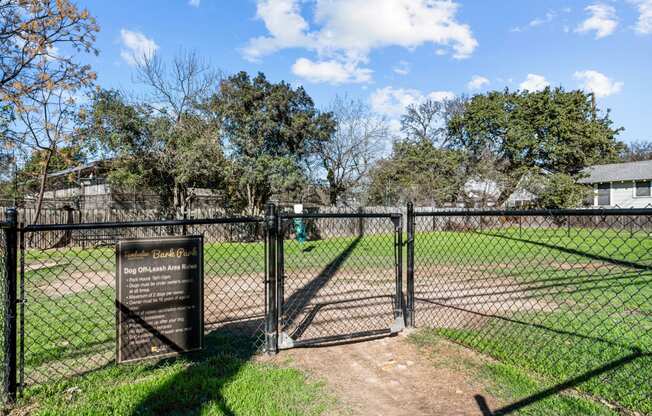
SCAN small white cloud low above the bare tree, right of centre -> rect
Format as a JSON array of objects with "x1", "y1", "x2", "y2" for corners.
[{"x1": 370, "y1": 87, "x2": 455, "y2": 118}]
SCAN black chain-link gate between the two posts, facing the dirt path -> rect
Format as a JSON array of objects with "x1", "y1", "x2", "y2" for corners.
[{"x1": 277, "y1": 213, "x2": 404, "y2": 349}]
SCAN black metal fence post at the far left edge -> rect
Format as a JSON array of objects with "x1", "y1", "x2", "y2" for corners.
[{"x1": 2, "y1": 208, "x2": 18, "y2": 402}]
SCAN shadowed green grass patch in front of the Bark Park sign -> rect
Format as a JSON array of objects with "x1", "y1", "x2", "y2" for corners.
[{"x1": 16, "y1": 337, "x2": 334, "y2": 416}]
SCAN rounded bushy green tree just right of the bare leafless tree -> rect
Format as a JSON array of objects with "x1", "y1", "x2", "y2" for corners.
[{"x1": 369, "y1": 139, "x2": 465, "y2": 206}]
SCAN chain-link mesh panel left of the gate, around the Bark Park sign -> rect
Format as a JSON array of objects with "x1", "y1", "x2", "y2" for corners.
[{"x1": 21, "y1": 221, "x2": 265, "y2": 384}]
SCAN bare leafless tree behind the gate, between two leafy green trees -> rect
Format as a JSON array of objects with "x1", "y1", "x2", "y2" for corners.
[{"x1": 315, "y1": 96, "x2": 388, "y2": 205}]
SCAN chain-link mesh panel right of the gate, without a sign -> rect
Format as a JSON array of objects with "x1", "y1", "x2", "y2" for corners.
[{"x1": 414, "y1": 211, "x2": 652, "y2": 413}]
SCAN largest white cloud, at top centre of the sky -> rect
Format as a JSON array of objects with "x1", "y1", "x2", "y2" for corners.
[{"x1": 242, "y1": 0, "x2": 478, "y2": 83}]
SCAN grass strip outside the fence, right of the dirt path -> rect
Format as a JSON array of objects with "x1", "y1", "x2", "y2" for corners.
[{"x1": 408, "y1": 329, "x2": 616, "y2": 416}]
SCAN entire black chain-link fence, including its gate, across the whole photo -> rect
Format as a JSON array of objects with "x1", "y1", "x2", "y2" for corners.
[{"x1": 0, "y1": 208, "x2": 652, "y2": 413}]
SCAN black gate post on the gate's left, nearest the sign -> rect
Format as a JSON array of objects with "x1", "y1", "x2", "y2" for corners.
[{"x1": 265, "y1": 203, "x2": 279, "y2": 355}]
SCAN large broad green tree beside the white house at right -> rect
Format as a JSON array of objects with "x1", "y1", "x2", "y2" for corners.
[{"x1": 448, "y1": 88, "x2": 622, "y2": 205}]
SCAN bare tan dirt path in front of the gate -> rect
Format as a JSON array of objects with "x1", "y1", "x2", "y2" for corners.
[{"x1": 278, "y1": 336, "x2": 497, "y2": 416}]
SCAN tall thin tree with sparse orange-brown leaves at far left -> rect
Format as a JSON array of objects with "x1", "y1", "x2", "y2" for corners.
[{"x1": 0, "y1": 0, "x2": 99, "y2": 222}]
